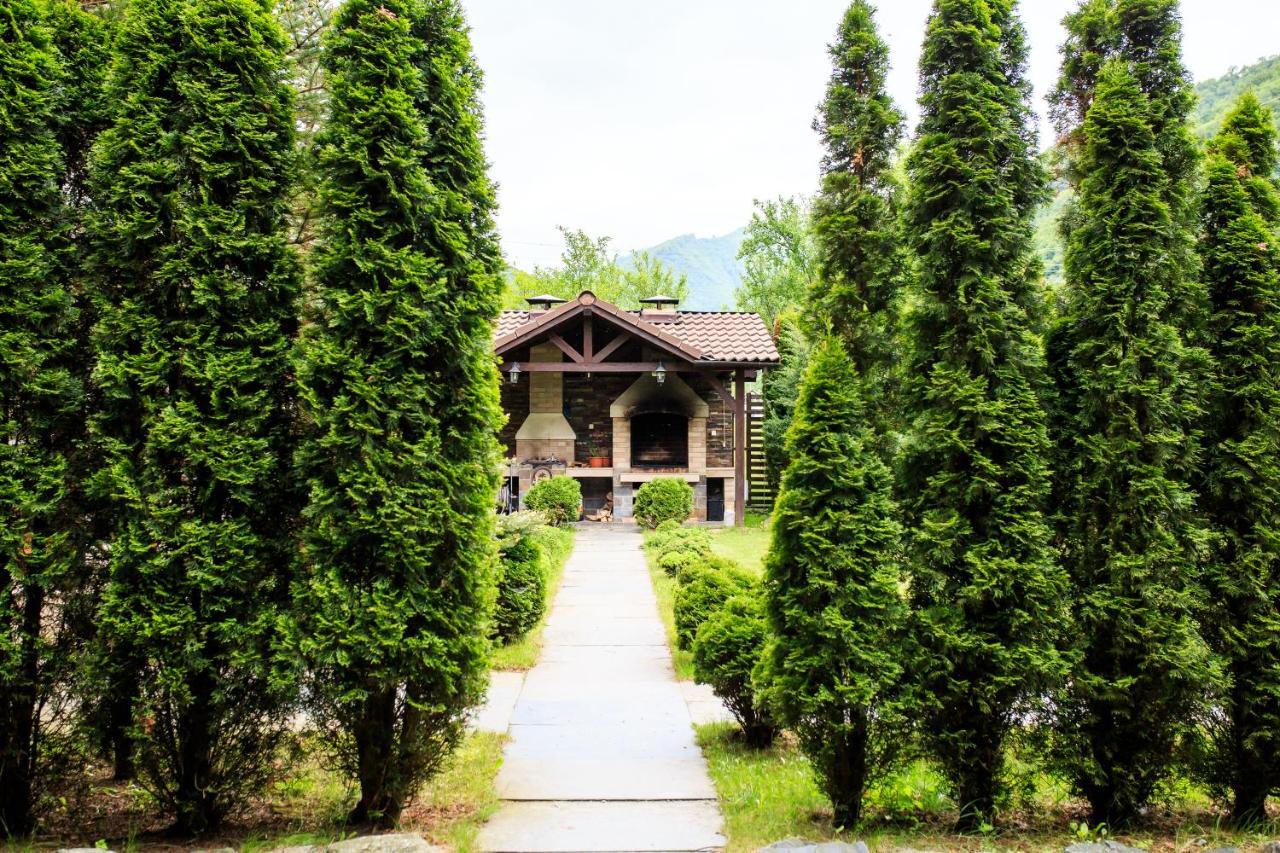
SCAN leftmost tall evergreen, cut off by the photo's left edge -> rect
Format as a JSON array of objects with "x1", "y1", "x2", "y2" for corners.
[{"x1": 0, "y1": 0, "x2": 83, "y2": 835}]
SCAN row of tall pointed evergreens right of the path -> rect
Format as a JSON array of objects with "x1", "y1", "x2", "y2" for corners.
[{"x1": 762, "y1": 0, "x2": 1280, "y2": 829}]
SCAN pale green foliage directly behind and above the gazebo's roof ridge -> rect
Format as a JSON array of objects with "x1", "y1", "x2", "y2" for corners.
[{"x1": 503, "y1": 227, "x2": 689, "y2": 310}]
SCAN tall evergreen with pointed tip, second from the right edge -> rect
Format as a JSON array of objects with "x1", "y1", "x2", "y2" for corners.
[{"x1": 1056, "y1": 61, "x2": 1213, "y2": 826}]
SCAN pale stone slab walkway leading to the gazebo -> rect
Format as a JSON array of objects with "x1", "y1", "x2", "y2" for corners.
[{"x1": 479, "y1": 530, "x2": 724, "y2": 853}]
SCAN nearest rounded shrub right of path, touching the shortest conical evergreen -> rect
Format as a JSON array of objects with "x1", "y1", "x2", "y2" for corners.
[{"x1": 694, "y1": 590, "x2": 778, "y2": 748}]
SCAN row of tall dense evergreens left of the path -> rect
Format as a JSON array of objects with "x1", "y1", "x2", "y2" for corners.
[{"x1": 0, "y1": 0, "x2": 500, "y2": 834}]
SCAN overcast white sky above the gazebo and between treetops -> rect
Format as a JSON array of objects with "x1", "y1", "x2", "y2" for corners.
[{"x1": 463, "y1": 0, "x2": 1280, "y2": 268}]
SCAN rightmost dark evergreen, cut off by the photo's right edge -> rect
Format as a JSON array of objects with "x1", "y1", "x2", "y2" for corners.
[{"x1": 1199, "y1": 95, "x2": 1280, "y2": 822}]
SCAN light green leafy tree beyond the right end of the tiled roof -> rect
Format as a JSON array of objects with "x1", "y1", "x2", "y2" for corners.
[{"x1": 737, "y1": 197, "x2": 819, "y2": 328}]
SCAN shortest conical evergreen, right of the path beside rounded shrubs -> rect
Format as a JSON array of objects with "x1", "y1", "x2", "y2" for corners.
[{"x1": 763, "y1": 338, "x2": 905, "y2": 826}]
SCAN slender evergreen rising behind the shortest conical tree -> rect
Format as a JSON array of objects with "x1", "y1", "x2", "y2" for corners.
[{"x1": 812, "y1": 0, "x2": 905, "y2": 384}]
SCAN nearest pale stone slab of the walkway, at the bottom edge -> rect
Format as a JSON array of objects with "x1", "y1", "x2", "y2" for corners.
[{"x1": 480, "y1": 800, "x2": 724, "y2": 853}]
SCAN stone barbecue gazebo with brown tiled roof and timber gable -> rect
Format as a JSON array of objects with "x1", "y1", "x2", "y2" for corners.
[{"x1": 494, "y1": 291, "x2": 778, "y2": 524}]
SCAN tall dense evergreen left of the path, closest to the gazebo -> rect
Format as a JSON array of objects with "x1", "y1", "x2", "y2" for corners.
[{"x1": 297, "y1": 0, "x2": 500, "y2": 825}]
